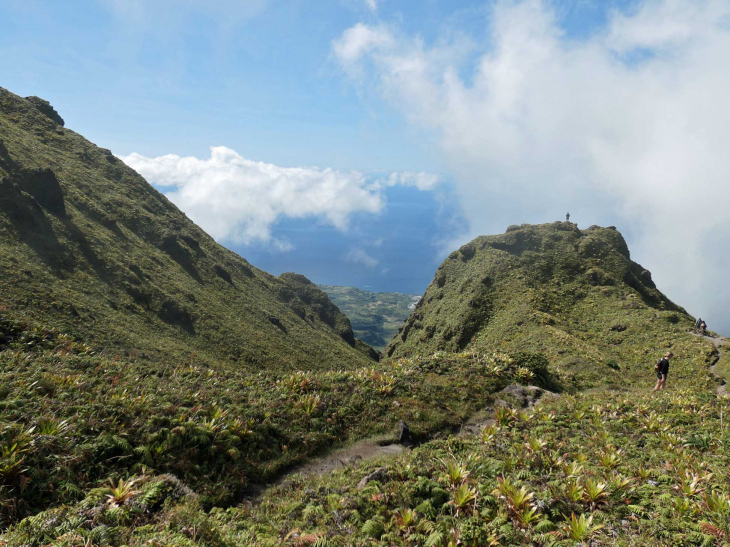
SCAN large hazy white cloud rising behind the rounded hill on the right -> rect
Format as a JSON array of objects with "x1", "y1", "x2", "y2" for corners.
[{"x1": 333, "y1": 0, "x2": 730, "y2": 329}]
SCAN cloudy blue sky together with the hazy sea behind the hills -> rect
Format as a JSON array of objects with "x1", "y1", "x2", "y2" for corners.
[{"x1": 0, "y1": 0, "x2": 730, "y2": 333}]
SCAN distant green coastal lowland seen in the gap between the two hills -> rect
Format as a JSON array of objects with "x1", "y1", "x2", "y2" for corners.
[{"x1": 320, "y1": 285, "x2": 420, "y2": 350}]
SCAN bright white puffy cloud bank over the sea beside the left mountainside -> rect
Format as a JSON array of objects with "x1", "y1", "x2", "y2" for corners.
[{"x1": 121, "y1": 146, "x2": 434, "y2": 251}]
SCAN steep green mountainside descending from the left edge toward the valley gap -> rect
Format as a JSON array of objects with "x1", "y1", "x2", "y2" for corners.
[{"x1": 0, "y1": 88, "x2": 377, "y2": 370}]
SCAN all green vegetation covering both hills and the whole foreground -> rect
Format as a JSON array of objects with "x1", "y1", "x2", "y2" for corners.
[{"x1": 0, "y1": 89, "x2": 730, "y2": 547}]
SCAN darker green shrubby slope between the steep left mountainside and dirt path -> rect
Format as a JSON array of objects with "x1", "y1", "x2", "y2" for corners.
[{"x1": 0, "y1": 310, "x2": 544, "y2": 525}]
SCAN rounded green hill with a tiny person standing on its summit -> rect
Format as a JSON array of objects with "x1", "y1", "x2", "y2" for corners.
[{"x1": 386, "y1": 222, "x2": 692, "y2": 388}]
